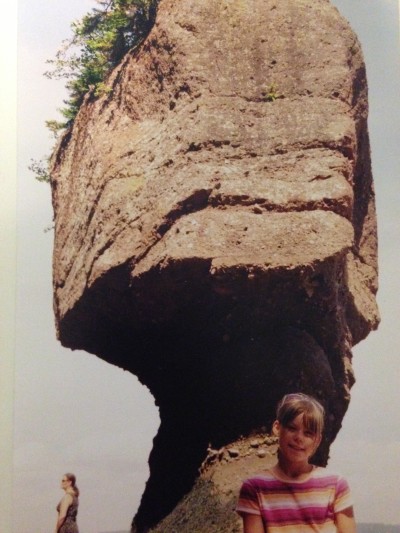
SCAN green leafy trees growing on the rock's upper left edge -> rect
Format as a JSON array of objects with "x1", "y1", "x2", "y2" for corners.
[{"x1": 29, "y1": 0, "x2": 159, "y2": 182}]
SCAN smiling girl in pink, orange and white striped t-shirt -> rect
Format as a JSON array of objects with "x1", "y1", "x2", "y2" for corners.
[{"x1": 236, "y1": 393, "x2": 356, "y2": 533}]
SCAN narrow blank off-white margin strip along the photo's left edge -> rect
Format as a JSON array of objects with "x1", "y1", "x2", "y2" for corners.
[{"x1": 0, "y1": 3, "x2": 17, "y2": 533}]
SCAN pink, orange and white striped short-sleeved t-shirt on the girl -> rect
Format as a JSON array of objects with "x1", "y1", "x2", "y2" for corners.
[{"x1": 236, "y1": 467, "x2": 353, "y2": 533}]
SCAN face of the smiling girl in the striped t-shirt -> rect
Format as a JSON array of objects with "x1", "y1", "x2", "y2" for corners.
[{"x1": 273, "y1": 413, "x2": 321, "y2": 463}]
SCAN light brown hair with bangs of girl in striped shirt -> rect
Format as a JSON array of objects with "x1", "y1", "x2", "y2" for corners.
[{"x1": 276, "y1": 392, "x2": 325, "y2": 435}]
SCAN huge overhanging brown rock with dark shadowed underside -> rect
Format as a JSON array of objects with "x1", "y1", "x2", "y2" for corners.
[{"x1": 52, "y1": 0, "x2": 379, "y2": 532}]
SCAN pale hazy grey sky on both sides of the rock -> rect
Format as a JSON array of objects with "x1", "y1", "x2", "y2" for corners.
[{"x1": 7, "y1": 0, "x2": 400, "y2": 533}]
